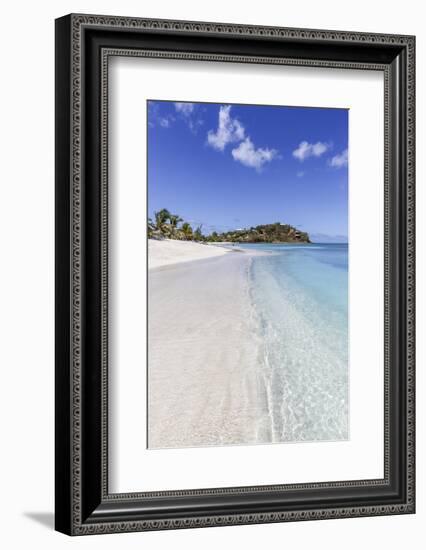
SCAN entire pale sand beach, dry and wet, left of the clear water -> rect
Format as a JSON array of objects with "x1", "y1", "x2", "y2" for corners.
[{"x1": 148, "y1": 252, "x2": 271, "y2": 448}]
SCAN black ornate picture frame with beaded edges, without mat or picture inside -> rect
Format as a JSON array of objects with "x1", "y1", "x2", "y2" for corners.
[{"x1": 55, "y1": 14, "x2": 415, "y2": 535}]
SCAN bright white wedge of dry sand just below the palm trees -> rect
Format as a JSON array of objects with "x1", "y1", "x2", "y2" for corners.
[{"x1": 148, "y1": 239, "x2": 229, "y2": 269}]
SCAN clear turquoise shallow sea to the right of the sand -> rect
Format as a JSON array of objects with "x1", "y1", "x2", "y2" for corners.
[{"x1": 235, "y1": 244, "x2": 349, "y2": 442}]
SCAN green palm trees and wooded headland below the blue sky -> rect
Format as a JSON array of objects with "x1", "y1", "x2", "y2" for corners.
[{"x1": 148, "y1": 208, "x2": 311, "y2": 243}]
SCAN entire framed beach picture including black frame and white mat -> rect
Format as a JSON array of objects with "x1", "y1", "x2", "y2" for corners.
[{"x1": 56, "y1": 14, "x2": 415, "y2": 535}]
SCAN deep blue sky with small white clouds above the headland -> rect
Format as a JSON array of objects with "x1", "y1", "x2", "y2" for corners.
[{"x1": 148, "y1": 101, "x2": 348, "y2": 241}]
